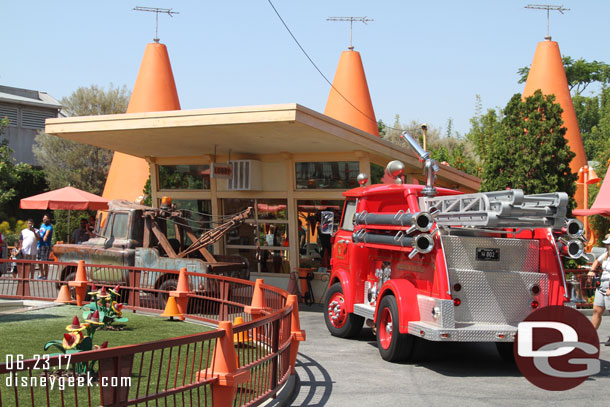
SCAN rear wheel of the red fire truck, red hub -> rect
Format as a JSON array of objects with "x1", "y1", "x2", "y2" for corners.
[{"x1": 376, "y1": 295, "x2": 415, "y2": 362}]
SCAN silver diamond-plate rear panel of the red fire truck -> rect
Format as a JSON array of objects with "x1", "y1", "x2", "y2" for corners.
[{"x1": 443, "y1": 236, "x2": 548, "y2": 324}]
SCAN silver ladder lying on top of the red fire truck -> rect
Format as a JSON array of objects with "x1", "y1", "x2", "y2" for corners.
[{"x1": 420, "y1": 189, "x2": 568, "y2": 229}]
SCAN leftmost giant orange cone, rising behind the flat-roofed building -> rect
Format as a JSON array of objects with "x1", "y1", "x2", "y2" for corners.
[{"x1": 102, "y1": 43, "x2": 180, "y2": 201}]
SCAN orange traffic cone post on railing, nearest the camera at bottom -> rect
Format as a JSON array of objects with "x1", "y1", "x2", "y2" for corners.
[{"x1": 197, "y1": 321, "x2": 250, "y2": 407}]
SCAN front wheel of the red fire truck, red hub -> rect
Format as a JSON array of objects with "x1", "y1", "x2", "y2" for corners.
[{"x1": 324, "y1": 282, "x2": 364, "y2": 338}]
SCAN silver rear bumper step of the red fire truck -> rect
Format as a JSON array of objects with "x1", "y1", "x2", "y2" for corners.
[{"x1": 409, "y1": 322, "x2": 517, "y2": 342}]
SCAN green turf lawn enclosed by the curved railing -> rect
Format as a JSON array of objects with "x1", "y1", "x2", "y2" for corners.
[{"x1": 0, "y1": 305, "x2": 213, "y2": 406}]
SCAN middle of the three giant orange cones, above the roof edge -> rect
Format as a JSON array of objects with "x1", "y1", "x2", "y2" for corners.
[{"x1": 324, "y1": 49, "x2": 379, "y2": 137}]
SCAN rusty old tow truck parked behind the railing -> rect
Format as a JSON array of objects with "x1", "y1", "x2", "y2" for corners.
[{"x1": 53, "y1": 200, "x2": 252, "y2": 300}]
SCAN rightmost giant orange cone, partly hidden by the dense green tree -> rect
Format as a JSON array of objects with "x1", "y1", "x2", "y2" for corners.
[{"x1": 523, "y1": 40, "x2": 587, "y2": 208}]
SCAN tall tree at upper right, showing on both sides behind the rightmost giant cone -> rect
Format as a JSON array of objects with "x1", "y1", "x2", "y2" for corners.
[{"x1": 517, "y1": 56, "x2": 610, "y2": 95}]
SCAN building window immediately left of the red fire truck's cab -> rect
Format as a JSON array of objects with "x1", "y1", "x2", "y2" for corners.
[{"x1": 297, "y1": 200, "x2": 343, "y2": 271}]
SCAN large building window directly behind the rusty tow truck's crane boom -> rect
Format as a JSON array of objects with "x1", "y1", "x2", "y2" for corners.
[{"x1": 222, "y1": 199, "x2": 290, "y2": 273}]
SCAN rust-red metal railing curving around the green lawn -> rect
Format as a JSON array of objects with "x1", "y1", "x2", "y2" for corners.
[{"x1": 0, "y1": 259, "x2": 304, "y2": 406}]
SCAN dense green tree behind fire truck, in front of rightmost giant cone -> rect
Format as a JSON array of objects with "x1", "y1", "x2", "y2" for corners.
[{"x1": 481, "y1": 90, "x2": 576, "y2": 202}]
